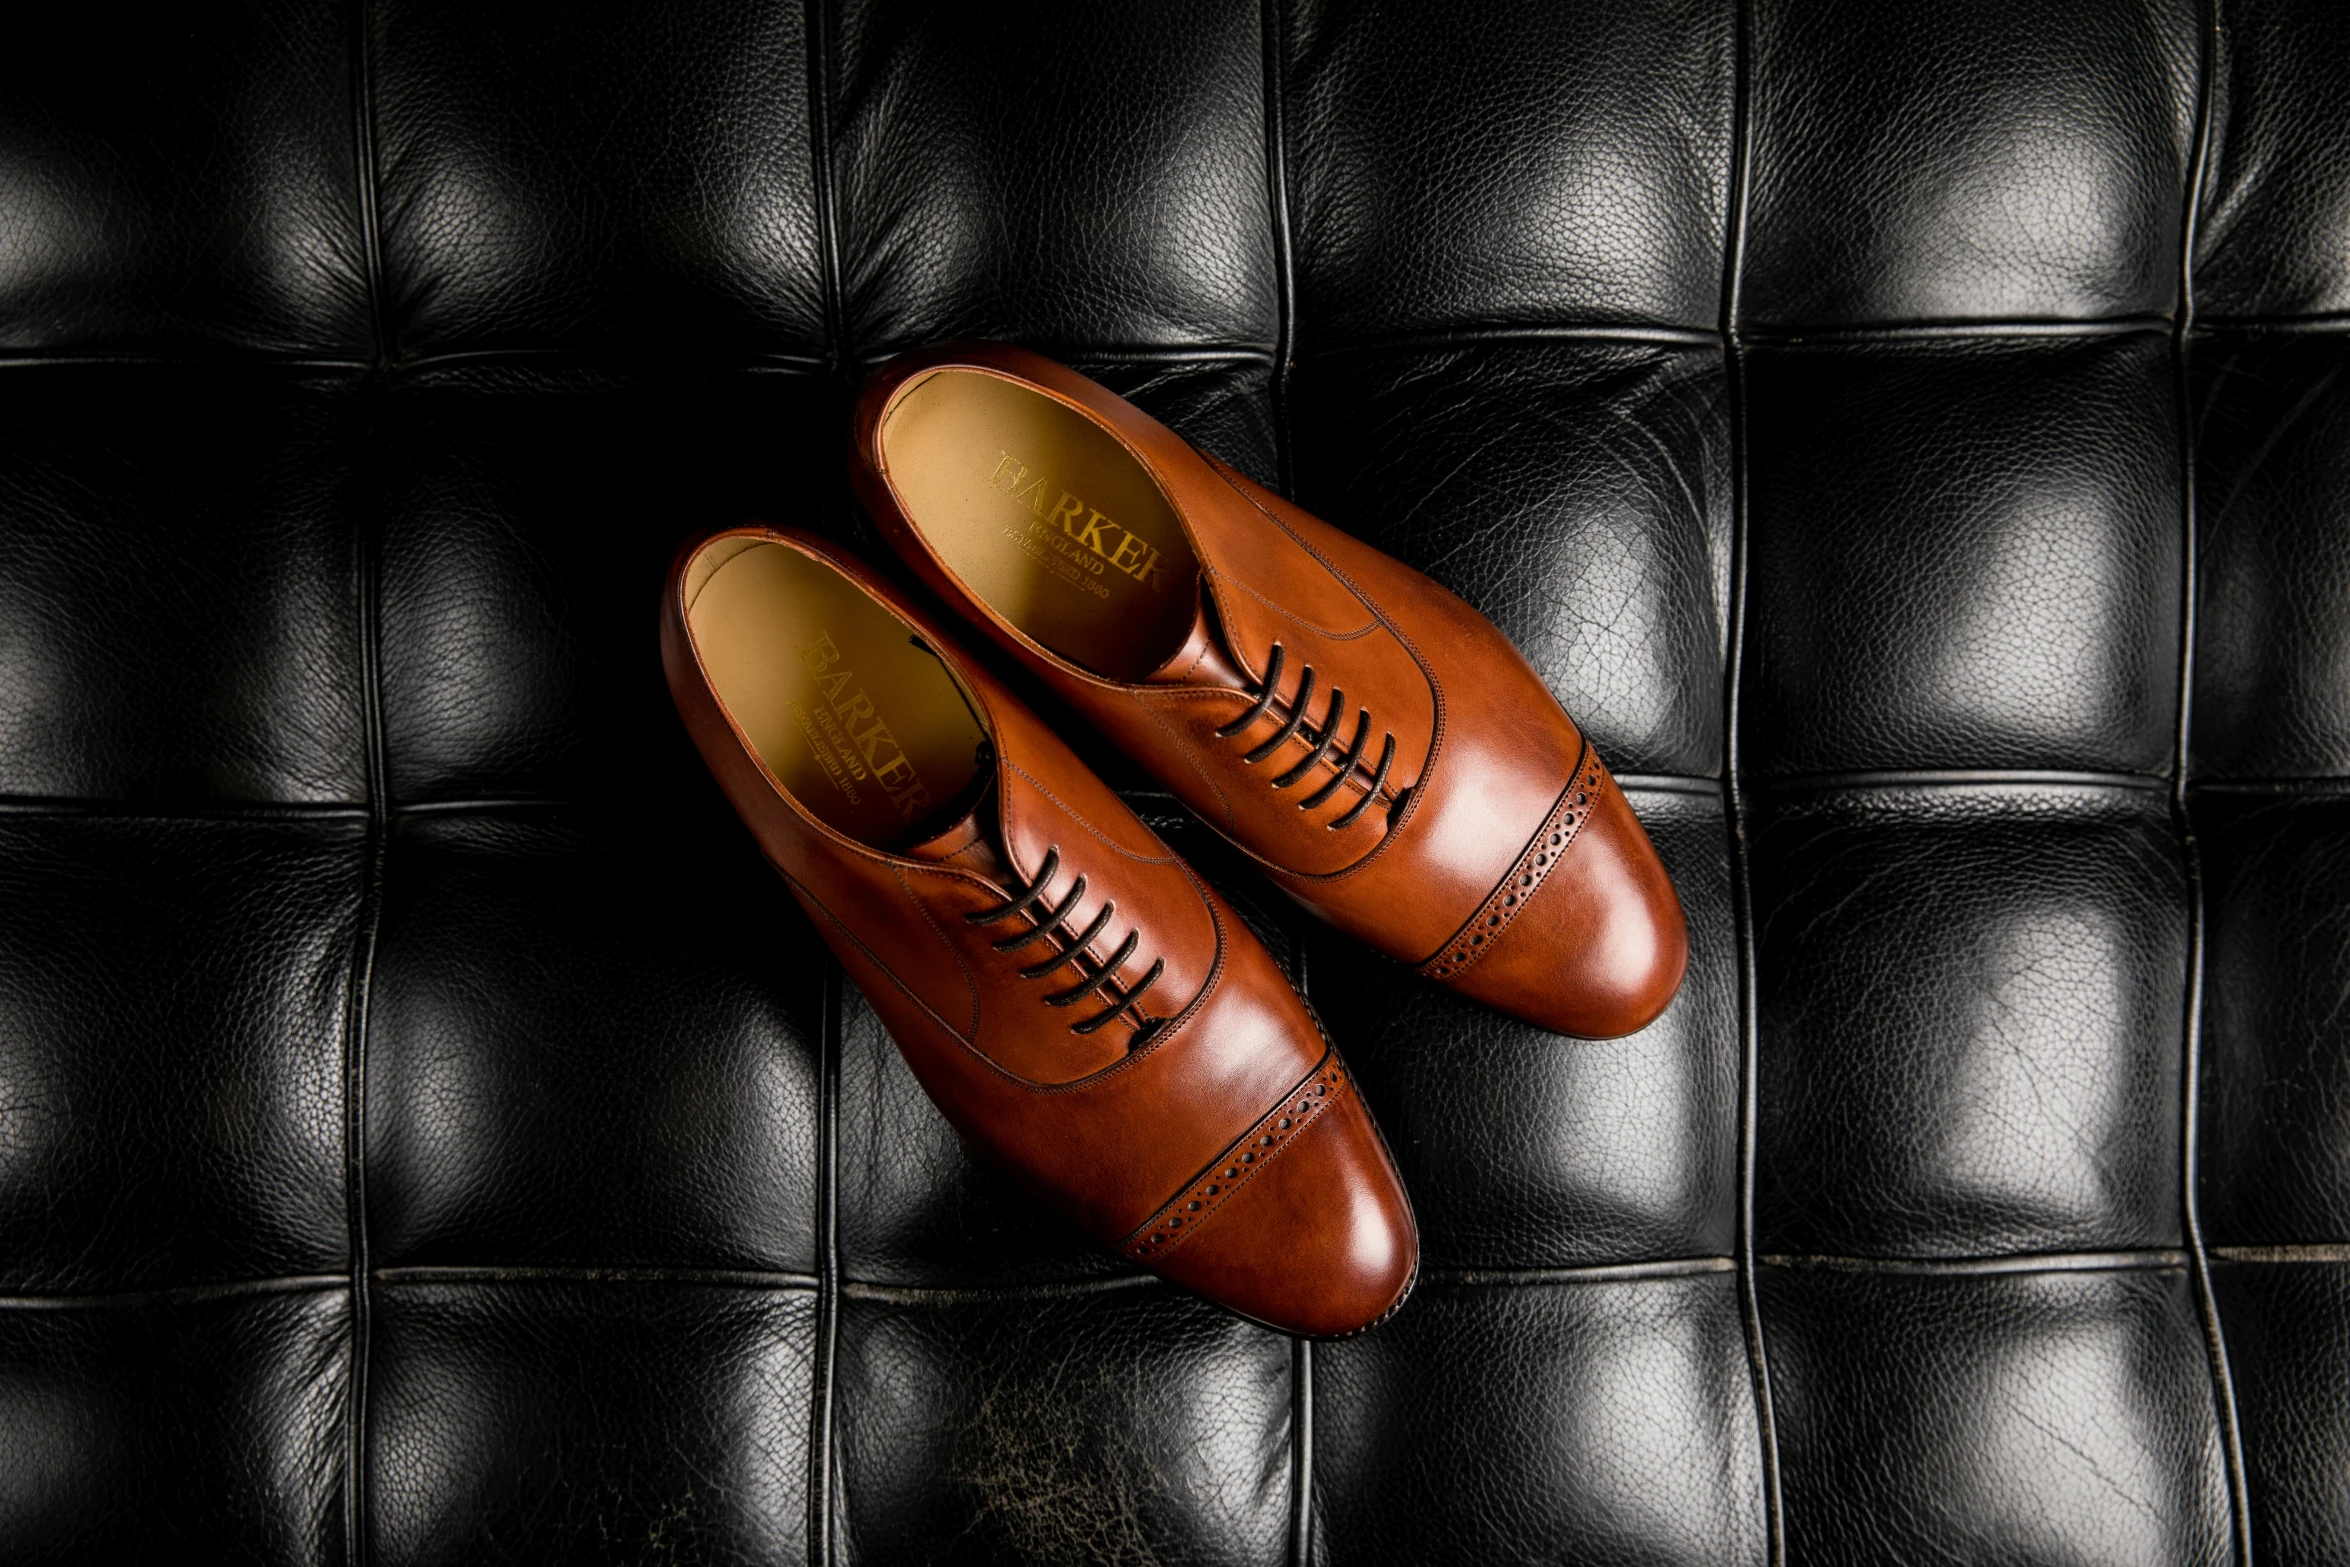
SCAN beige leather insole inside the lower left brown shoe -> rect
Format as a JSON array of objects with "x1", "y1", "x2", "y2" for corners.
[{"x1": 686, "y1": 540, "x2": 987, "y2": 848}]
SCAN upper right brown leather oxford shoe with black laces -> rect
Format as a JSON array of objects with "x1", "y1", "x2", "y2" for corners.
[{"x1": 851, "y1": 343, "x2": 1690, "y2": 1038}]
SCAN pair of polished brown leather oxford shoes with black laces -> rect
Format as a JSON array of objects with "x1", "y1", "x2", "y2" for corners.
[{"x1": 660, "y1": 343, "x2": 1687, "y2": 1337}]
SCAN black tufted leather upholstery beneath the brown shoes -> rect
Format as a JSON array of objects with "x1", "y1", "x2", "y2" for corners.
[{"x1": 0, "y1": 0, "x2": 2350, "y2": 1567}]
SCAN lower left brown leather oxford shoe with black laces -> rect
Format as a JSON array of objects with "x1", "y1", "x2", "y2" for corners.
[{"x1": 660, "y1": 526, "x2": 1419, "y2": 1337}]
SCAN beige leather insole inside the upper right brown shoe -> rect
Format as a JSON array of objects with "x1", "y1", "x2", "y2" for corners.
[{"x1": 881, "y1": 369, "x2": 1199, "y2": 681}]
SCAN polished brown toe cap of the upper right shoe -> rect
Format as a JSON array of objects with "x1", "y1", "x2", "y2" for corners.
[{"x1": 1445, "y1": 778, "x2": 1690, "y2": 1038}]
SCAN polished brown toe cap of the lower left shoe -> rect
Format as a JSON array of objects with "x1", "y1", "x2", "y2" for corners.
[{"x1": 1154, "y1": 1092, "x2": 1419, "y2": 1339}]
